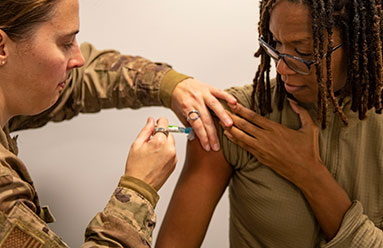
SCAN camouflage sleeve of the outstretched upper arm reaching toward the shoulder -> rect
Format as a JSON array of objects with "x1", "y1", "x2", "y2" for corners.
[{"x1": 9, "y1": 43, "x2": 188, "y2": 131}]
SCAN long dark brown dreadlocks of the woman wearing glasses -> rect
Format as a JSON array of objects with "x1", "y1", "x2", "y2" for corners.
[{"x1": 252, "y1": 0, "x2": 383, "y2": 128}]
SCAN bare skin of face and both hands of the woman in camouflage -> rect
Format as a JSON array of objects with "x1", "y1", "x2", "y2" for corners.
[{"x1": 0, "y1": 0, "x2": 236, "y2": 190}]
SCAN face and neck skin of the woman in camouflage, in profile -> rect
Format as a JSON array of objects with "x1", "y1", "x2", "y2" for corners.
[{"x1": 0, "y1": 0, "x2": 84, "y2": 126}]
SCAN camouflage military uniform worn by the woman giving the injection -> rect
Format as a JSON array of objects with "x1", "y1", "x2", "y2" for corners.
[{"x1": 0, "y1": 41, "x2": 187, "y2": 248}]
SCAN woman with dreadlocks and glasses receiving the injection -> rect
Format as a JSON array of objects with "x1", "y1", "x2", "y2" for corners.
[{"x1": 157, "y1": 0, "x2": 383, "y2": 248}]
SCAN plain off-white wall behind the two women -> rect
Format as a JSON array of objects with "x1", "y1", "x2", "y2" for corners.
[{"x1": 18, "y1": 0, "x2": 259, "y2": 248}]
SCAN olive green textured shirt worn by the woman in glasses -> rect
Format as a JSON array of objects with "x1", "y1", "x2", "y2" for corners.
[{"x1": 220, "y1": 85, "x2": 383, "y2": 248}]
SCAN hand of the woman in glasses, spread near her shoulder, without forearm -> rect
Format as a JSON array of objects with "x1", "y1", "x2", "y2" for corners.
[{"x1": 224, "y1": 101, "x2": 323, "y2": 187}]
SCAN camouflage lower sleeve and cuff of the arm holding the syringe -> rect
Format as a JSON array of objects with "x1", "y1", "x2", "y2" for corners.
[{"x1": 82, "y1": 177, "x2": 158, "y2": 248}]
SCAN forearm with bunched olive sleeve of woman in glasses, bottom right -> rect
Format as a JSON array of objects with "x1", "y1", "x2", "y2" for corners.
[{"x1": 302, "y1": 166, "x2": 383, "y2": 248}]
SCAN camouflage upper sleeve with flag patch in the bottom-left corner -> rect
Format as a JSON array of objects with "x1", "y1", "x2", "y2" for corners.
[{"x1": 0, "y1": 142, "x2": 68, "y2": 248}]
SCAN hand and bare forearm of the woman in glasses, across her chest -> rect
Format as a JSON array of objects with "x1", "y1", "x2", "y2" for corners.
[{"x1": 225, "y1": 101, "x2": 351, "y2": 240}]
